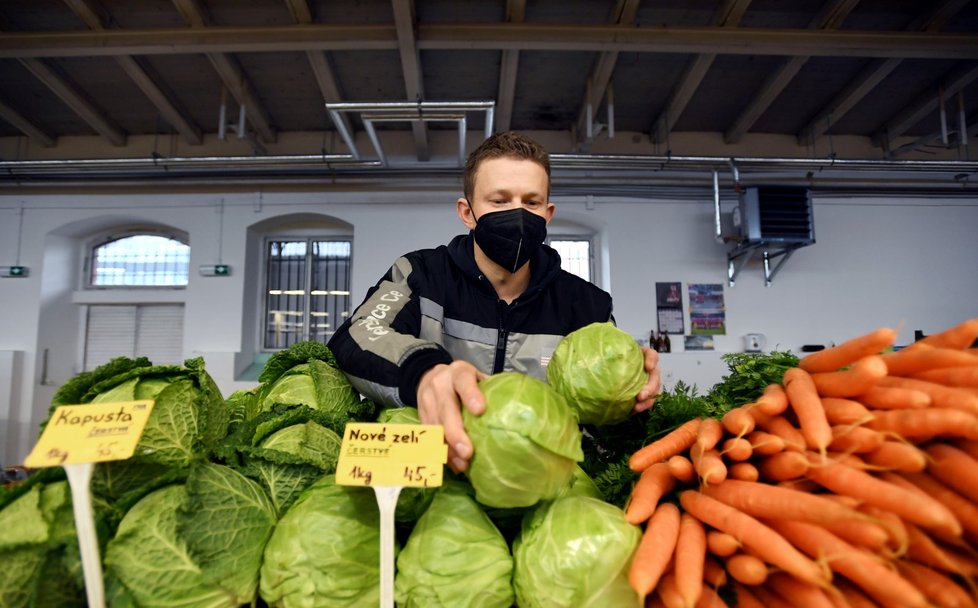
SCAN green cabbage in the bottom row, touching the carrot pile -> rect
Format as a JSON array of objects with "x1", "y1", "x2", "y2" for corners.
[{"x1": 513, "y1": 496, "x2": 642, "y2": 608}]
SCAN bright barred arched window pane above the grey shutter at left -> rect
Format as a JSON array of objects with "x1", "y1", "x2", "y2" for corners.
[{"x1": 89, "y1": 233, "x2": 190, "y2": 287}]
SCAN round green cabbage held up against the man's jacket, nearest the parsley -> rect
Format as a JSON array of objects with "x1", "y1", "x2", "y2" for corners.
[{"x1": 547, "y1": 322, "x2": 648, "y2": 425}]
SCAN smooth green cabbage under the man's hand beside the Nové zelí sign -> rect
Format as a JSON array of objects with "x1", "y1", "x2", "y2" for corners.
[{"x1": 462, "y1": 372, "x2": 584, "y2": 508}]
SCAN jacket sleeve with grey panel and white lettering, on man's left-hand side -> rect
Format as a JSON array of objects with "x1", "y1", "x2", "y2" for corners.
[{"x1": 328, "y1": 256, "x2": 452, "y2": 407}]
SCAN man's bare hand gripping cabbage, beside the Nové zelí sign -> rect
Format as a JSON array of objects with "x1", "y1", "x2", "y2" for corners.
[{"x1": 418, "y1": 361, "x2": 487, "y2": 473}]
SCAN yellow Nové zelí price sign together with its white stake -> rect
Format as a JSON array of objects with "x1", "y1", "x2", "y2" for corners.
[{"x1": 336, "y1": 422, "x2": 448, "y2": 608}]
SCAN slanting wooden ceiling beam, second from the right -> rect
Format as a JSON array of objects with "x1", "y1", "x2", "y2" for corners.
[{"x1": 797, "y1": 0, "x2": 970, "y2": 146}]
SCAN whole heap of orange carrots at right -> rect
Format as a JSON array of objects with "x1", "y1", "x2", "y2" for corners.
[{"x1": 625, "y1": 318, "x2": 978, "y2": 608}]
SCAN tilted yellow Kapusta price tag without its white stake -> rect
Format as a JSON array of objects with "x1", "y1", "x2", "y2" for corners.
[{"x1": 24, "y1": 400, "x2": 153, "y2": 468}]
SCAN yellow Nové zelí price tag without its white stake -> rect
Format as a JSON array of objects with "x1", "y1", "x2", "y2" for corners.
[{"x1": 336, "y1": 422, "x2": 448, "y2": 488}]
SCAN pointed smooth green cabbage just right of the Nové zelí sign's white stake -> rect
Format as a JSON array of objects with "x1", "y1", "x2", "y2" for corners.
[{"x1": 394, "y1": 481, "x2": 514, "y2": 608}]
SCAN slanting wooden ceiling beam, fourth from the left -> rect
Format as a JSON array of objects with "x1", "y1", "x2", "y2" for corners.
[{"x1": 172, "y1": 0, "x2": 278, "y2": 143}]
